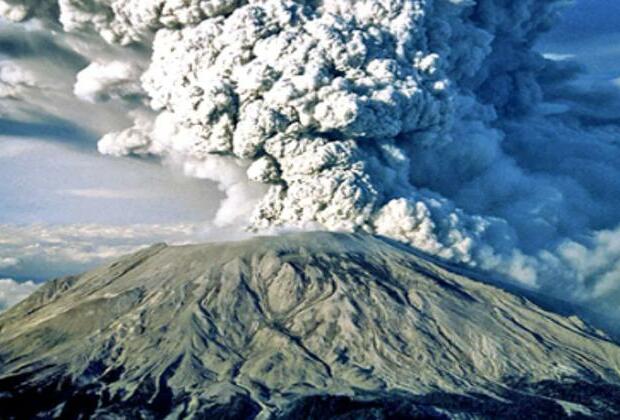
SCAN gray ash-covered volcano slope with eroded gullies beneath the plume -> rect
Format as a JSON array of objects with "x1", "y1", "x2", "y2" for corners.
[{"x1": 0, "y1": 233, "x2": 620, "y2": 419}]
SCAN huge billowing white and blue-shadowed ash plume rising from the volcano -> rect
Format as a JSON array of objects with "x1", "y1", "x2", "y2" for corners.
[{"x1": 0, "y1": 0, "x2": 620, "y2": 332}]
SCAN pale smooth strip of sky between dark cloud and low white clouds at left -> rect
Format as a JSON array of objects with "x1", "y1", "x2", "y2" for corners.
[{"x1": 0, "y1": 137, "x2": 219, "y2": 224}]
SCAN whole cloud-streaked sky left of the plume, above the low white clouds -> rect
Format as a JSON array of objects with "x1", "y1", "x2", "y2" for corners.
[{"x1": 0, "y1": 18, "x2": 220, "y2": 225}]
